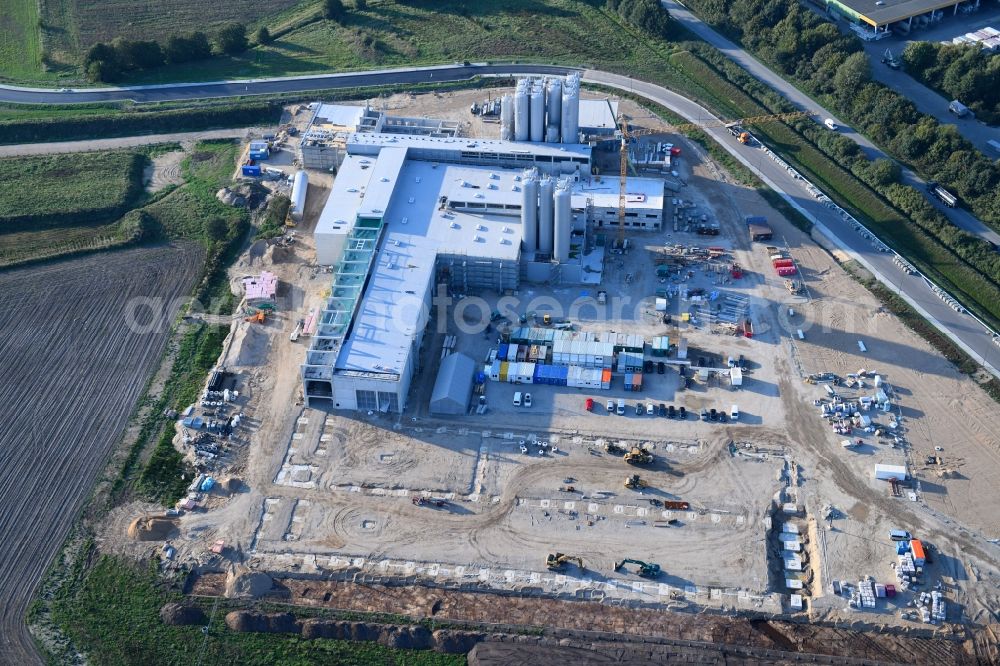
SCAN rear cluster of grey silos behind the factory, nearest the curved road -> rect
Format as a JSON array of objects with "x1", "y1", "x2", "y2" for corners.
[{"x1": 500, "y1": 74, "x2": 580, "y2": 143}]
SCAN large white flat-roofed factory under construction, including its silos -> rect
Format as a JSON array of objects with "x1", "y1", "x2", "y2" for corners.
[{"x1": 302, "y1": 76, "x2": 666, "y2": 412}]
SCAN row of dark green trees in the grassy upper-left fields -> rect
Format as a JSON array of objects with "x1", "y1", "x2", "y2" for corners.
[{"x1": 83, "y1": 23, "x2": 250, "y2": 82}]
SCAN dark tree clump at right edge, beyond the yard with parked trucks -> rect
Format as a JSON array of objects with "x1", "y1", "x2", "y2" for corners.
[{"x1": 903, "y1": 42, "x2": 1000, "y2": 124}]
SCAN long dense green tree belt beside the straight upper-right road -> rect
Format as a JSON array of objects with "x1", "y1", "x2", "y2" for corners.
[{"x1": 689, "y1": 0, "x2": 1000, "y2": 226}]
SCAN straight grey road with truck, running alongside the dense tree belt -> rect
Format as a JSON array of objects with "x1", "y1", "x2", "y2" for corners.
[{"x1": 662, "y1": 0, "x2": 1000, "y2": 246}]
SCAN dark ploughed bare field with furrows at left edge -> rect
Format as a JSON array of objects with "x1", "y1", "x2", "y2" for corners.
[{"x1": 0, "y1": 245, "x2": 202, "y2": 664}]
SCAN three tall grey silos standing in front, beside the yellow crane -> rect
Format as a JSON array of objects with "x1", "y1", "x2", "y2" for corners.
[{"x1": 521, "y1": 169, "x2": 573, "y2": 262}]
